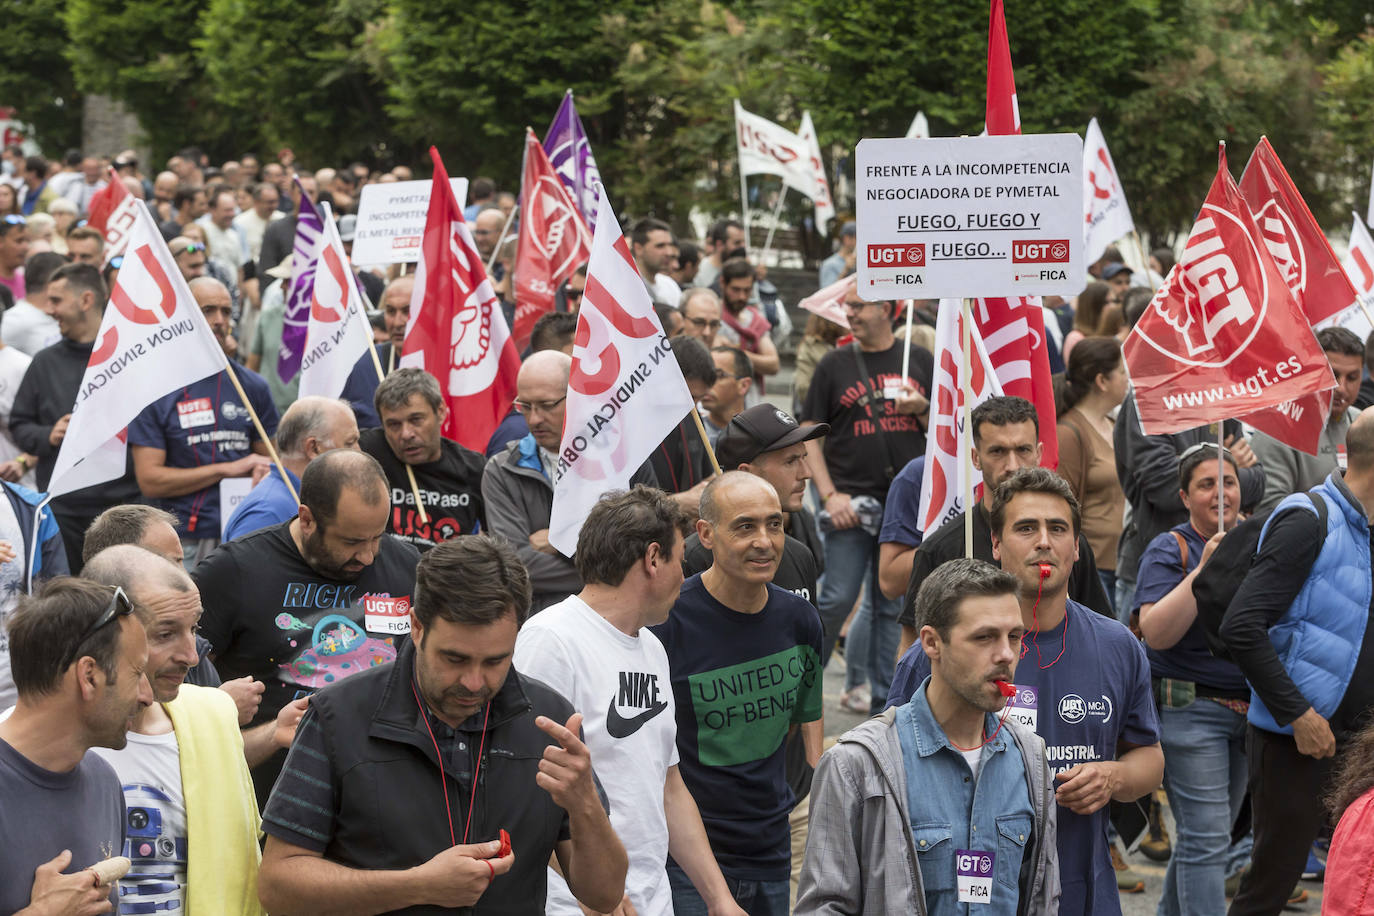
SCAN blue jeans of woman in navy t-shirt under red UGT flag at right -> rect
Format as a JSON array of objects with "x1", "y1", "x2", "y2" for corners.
[{"x1": 1158, "y1": 699, "x2": 1246, "y2": 916}]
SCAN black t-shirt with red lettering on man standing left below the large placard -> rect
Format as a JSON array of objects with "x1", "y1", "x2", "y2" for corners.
[{"x1": 798, "y1": 341, "x2": 934, "y2": 503}]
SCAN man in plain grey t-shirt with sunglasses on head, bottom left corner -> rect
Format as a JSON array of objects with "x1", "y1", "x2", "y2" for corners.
[{"x1": 0, "y1": 578, "x2": 153, "y2": 915}]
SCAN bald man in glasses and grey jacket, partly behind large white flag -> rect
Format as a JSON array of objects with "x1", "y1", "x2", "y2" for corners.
[{"x1": 478, "y1": 351, "x2": 658, "y2": 614}]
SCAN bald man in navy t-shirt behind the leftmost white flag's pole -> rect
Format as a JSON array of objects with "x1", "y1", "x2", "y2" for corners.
[{"x1": 129, "y1": 277, "x2": 278, "y2": 570}]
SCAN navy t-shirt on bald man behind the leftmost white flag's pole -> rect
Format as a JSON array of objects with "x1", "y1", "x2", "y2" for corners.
[{"x1": 129, "y1": 367, "x2": 278, "y2": 540}]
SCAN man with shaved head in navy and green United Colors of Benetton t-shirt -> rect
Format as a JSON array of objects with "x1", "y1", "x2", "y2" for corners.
[{"x1": 653, "y1": 471, "x2": 823, "y2": 915}]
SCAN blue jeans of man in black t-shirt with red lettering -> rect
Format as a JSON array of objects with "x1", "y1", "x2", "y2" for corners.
[{"x1": 820, "y1": 526, "x2": 901, "y2": 709}]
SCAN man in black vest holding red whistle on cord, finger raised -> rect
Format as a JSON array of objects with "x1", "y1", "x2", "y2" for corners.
[{"x1": 258, "y1": 538, "x2": 627, "y2": 916}]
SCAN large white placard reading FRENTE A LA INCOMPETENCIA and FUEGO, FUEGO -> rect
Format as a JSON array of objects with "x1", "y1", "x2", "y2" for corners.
[{"x1": 855, "y1": 133, "x2": 1084, "y2": 301}]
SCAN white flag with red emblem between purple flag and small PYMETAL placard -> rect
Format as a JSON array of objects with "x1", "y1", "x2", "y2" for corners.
[{"x1": 301, "y1": 203, "x2": 372, "y2": 397}]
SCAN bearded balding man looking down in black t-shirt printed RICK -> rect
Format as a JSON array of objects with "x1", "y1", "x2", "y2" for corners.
[{"x1": 192, "y1": 449, "x2": 419, "y2": 805}]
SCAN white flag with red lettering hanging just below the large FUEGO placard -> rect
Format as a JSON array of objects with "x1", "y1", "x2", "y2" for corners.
[{"x1": 916, "y1": 299, "x2": 1002, "y2": 534}]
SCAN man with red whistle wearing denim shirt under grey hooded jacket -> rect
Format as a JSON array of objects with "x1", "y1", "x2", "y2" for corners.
[{"x1": 796, "y1": 559, "x2": 1059, "y2": 916}]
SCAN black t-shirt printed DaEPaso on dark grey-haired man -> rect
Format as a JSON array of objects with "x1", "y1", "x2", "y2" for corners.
[{"x1": 357, "y1": 428, "x2": 486, "y2": 552}]
